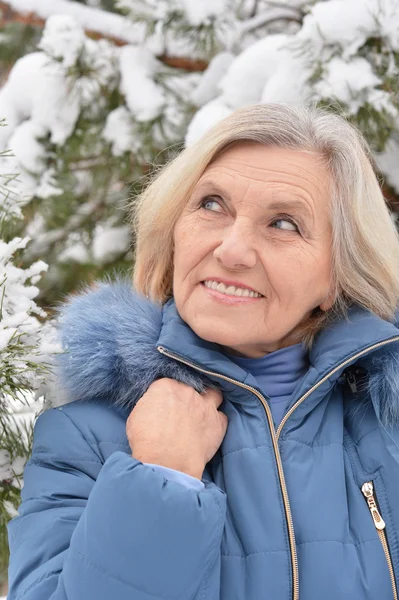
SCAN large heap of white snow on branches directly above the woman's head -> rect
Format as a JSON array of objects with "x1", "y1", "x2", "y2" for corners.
[{"x1": 185, "y1": 0, "x2": 399, "y2": 155}]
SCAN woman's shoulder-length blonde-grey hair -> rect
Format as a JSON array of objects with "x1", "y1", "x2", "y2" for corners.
[{"x1": 131, "y1": 104, "x2": 399, "y2": 347}]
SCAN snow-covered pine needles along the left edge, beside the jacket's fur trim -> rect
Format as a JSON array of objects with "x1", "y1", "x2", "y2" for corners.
[{"x1": 0, "y1": 122, "x2": 60, "y2": 586}]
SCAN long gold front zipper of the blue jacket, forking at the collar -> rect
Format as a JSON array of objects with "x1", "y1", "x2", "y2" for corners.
[{"x1": 157, "y1": 335, "x2": 399, "y2": 600}]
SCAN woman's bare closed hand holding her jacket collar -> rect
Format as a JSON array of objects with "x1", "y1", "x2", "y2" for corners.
[{"x1": 126, "y1": 377, "x2": 227, "y2": 479}]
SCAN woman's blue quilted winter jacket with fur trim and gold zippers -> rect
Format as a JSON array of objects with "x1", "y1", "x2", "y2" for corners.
[{"x1": 8, "y1": 280, "x2": 399, "y2": 600}]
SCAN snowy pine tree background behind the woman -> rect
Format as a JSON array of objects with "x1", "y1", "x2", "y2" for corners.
[{"x1": 0, "y1": 0, "x2": 399, "y2": 600}]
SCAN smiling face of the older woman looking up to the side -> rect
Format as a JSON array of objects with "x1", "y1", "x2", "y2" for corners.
[{"x1": 173, "y1": 143, "x2": 334, "y2": 358}]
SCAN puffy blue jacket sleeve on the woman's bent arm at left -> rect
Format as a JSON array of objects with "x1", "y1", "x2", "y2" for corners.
[{"x1": 7, "y1": 409, "x2": 226, "y2": 600}]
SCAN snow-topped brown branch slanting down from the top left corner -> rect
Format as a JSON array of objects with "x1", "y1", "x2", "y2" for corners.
[{"x1": 0, "y1": 0, "x2": 208, "y2": 72}]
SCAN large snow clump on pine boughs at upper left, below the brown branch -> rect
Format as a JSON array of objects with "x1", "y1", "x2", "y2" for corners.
[{"x1": 0, "y1": 15, "x2": 119, "y2": 198}]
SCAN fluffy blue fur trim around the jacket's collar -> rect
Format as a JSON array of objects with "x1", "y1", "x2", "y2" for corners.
[{"x1": 56, "y1": 276, "x2": 399, "y2": 425}]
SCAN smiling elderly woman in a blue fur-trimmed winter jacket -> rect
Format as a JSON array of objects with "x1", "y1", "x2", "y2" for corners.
[{"x1": 8, "y1": 105, "x2": 399, "y2": 600}]
